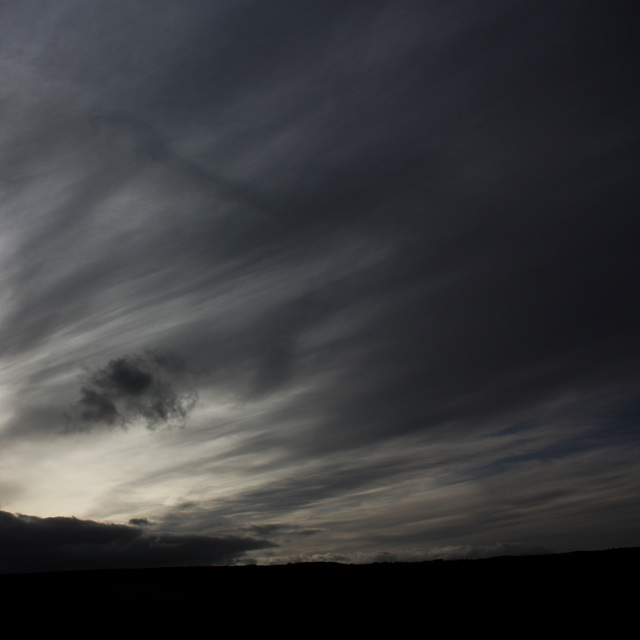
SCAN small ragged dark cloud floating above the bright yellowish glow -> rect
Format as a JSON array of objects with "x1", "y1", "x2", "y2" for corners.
[{"x1": 68, "y1": 351, "x2": 197, "y2": 431}]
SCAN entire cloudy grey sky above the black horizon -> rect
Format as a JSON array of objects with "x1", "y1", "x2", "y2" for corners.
[{"x1": 0, "y1": 0, "x2": 640, "y2": 572}]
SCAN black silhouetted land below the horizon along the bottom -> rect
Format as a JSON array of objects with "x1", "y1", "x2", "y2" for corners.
[{"x1": 0, "y1": 548, "x2": 640, "y2": 637}]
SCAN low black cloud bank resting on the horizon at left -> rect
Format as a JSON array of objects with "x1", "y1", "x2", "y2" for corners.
[{"x1": 0, "y1": 511, "x2": 270, "y2": 573}]
